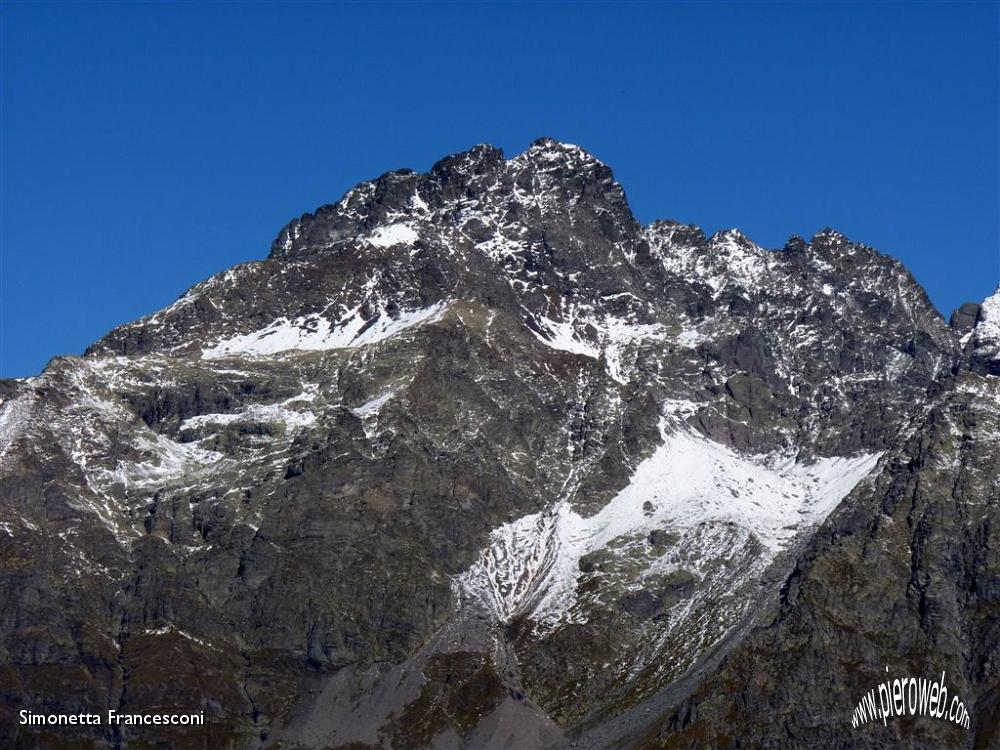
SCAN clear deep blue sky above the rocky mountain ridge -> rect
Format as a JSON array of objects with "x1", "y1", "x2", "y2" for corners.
[{"x1": 0, "y1": 2, "x2": 1000, "y2": 376}]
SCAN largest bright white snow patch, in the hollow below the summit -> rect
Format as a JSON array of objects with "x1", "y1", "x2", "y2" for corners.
[{"x1": 458, "y1": 429, "x2": 881, "y2": 625}]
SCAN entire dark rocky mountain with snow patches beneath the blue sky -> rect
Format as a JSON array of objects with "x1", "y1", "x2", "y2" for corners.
[{"x1": 0, "y1": 139, "x2": 1000, "y2": 750}]
